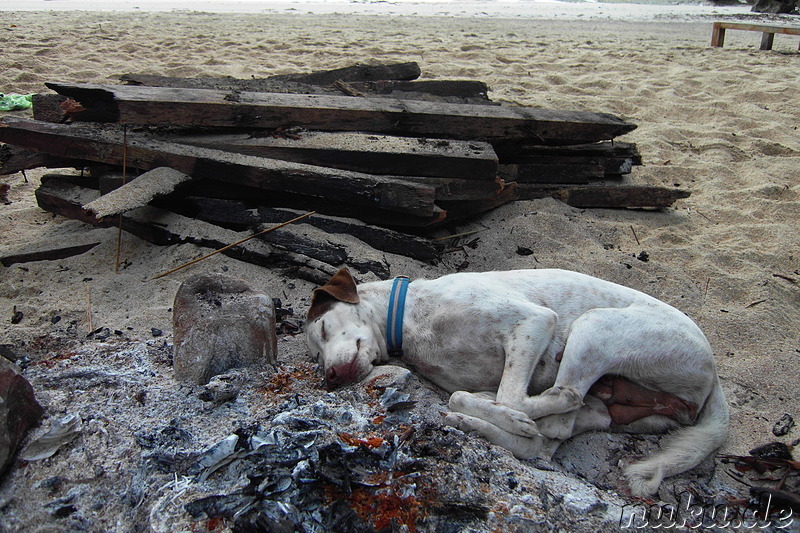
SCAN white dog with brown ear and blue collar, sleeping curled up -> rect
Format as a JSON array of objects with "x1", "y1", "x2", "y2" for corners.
[{"x1": 306, "y1": 269, "x2": 728, "y2": 496}]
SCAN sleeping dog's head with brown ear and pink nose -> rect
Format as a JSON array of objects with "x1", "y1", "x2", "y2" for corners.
[{"x1": 306, "y1": 268, "x2": 381, "y2": 388}]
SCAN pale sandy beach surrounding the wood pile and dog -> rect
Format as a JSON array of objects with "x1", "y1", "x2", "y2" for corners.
[{"x1": 0, "y1": 2, "x2": 800, "y2": 529}]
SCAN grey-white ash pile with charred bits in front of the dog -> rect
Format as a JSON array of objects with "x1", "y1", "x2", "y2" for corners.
[{"x1": 0, "y1": 337, "x2": 652, "y2": 532}]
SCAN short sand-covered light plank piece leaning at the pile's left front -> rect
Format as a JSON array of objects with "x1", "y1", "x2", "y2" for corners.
[{"x1": 83, "y1": 167, "x2": 192, "y2": 218}]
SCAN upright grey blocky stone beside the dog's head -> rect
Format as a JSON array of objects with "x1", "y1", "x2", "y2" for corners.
[{"x1": 172, "y1": 274, "x2": 278, "y2": 385}]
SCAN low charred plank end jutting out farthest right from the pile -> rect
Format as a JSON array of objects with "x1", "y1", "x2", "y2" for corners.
[{"x1": 519, "y1": 184, "x2": 691, "y2": 208}]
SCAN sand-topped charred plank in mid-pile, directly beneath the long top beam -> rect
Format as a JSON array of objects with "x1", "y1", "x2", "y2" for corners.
[{"x1": 171, "y1": 130, "x2": 497, "y2": 180}]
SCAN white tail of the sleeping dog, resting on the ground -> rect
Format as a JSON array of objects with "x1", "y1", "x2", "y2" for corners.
[{"x1": 625, "y1": 378, "x2": 729, "y2": 497}]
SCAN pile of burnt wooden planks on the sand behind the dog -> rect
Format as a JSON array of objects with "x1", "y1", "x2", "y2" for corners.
[{"x1": 0, "y1": 63, "x2": 688, "y2": 279}]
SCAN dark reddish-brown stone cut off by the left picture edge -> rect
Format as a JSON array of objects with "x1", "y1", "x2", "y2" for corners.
[{"x1": 0, "y1": 357, "x2": 44, "y2": 476}]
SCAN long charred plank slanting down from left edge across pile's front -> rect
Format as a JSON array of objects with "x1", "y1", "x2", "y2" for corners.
[{"x1": 0, "y1": 117, "x2": 436, "y2": 217}]
